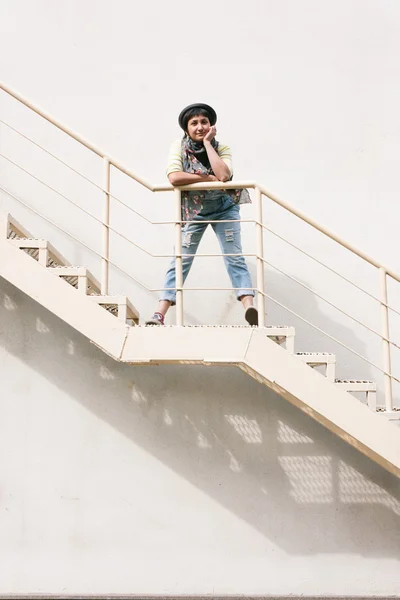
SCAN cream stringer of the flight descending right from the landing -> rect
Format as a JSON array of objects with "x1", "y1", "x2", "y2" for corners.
[{"x1": 238, "y1": 330, "x2": 400, "y2": 477}]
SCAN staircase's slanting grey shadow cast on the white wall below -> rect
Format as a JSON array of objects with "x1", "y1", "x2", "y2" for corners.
[{"x1": 0, "y1": 279, "x2": 400, "y2": 559}]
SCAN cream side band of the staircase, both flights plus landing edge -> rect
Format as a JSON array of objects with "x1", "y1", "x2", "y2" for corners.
[{"x1": 0, "y1": 213, "x2": 400, "y2": 476}]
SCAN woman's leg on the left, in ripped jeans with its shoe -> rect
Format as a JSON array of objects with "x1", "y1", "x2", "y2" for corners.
[{"x1": 146, "y1": 221, "x2": 207, "y2": 325}]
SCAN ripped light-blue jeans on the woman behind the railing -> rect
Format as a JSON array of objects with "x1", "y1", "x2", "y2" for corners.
[{"x1": 160, "y1": 195, "x2": 254, "y2": 304}]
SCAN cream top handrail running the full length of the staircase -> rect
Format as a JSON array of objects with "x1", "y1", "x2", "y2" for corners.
[{"x1": 0, "y1": 81, "x2": 400, "y2": 283}]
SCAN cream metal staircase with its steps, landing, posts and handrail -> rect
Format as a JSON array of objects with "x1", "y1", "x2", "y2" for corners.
[{"x1": 0, "y1": 79, "x2": 400, "y2": 477}]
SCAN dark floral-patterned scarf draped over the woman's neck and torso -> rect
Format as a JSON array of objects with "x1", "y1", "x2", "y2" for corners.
[{"x1": 181, "y1": 134, "x2": 251, "y2": 221}]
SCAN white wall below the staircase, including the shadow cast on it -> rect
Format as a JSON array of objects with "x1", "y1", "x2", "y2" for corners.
[{"x1": 0, "y1": 280, "x2": 400, "y2": 597}]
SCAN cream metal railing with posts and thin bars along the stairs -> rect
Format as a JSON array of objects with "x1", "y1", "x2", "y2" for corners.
[{"x1": 0, "y1": 82, "x2": 400, "y2": 411}]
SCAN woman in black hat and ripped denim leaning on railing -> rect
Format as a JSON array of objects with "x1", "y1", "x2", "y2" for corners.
[{"x1": 146, "y1": 104, "x2": 258, "y2": 325}]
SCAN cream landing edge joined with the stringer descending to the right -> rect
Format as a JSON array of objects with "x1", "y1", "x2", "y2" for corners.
[{"x1": 121, "y1": 327, "x2": 400, "y2": 477}]
